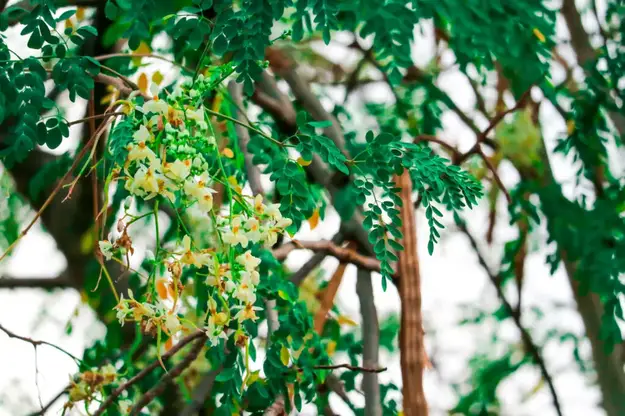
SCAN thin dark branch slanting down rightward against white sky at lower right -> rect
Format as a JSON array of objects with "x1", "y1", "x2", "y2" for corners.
[{"x1": 456, "y1": 221, "x2": 562, "y2": 416}]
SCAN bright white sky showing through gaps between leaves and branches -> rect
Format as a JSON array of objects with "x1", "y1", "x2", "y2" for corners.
[{"x1": 0, "y1": 2, "x2": 620, "y2": 416}]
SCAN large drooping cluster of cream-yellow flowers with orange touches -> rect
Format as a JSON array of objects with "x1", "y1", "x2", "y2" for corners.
[{"x1": 99, "y1": 80, "x2": 292, "y2": 354}]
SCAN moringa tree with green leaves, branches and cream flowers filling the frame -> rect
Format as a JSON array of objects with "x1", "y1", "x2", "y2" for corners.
[{"x1": 0, "y1": 0, "x2": 625, "y2": 416}]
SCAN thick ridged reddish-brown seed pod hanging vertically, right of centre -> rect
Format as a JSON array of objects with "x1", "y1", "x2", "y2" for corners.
[{"x1": 395, "y1": 171, "x2": 428, "y2": 416}]
